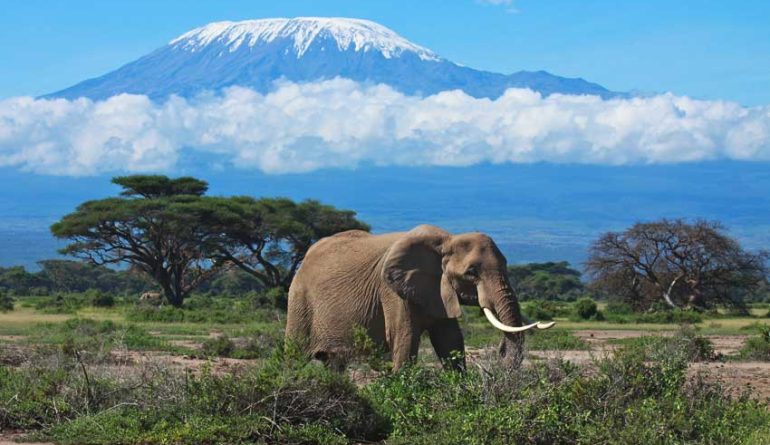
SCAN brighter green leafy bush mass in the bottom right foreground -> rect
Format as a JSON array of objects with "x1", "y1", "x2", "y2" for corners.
[{"x1": 364, "y1": 351, "x2": 770, "y2": 444}]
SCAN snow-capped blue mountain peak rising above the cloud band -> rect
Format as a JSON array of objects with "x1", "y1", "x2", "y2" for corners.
[{"x1": 44, "y1": 18, "x2": 622, "y2": 100}]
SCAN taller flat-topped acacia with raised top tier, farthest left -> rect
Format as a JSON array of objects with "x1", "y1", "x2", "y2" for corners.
[{"x1": 51, "y1": 175, "x2": 222, "y2": 307}]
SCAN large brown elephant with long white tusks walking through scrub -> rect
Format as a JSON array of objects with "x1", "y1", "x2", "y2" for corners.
[{"x1": 286, "y1": 225, "x2": 553, "y2": 369}]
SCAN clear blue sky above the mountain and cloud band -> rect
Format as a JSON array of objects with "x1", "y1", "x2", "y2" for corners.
[{"x1": 0, "y1": 0, "x2": 770, "y2": 105}]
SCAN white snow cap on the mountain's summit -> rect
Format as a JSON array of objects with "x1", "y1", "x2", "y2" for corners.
[{"x1": 169, "y1": 17, "x2": 439, "y2": 61}]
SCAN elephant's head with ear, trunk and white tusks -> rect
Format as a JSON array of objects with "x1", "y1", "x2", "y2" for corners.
[{"x1": 382, "y1": 225, "x2": 553, "y2": 366}]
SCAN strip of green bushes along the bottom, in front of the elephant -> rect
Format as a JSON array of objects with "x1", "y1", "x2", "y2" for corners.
[{"x1": 0, "y1": 328, "x2": 770, "y2": 444}]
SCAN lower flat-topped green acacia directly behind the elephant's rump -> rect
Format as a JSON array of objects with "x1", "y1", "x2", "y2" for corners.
[{"x1": 205, "y1": 196, "x2": 369, "y2": 290}]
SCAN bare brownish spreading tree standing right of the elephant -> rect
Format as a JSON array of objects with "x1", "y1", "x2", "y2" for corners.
[{"x1": 586, "y1": 219, "x2": 768, "y2": 309}]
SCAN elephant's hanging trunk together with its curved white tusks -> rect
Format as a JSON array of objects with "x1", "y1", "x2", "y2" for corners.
[{"x1": 477, "y1": 274, "x2": 553, "y2": 368}]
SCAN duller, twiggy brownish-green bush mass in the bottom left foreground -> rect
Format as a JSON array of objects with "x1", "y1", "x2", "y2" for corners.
[{"x1": 0, "y1": 348, "x2": 389, "y2": 444}]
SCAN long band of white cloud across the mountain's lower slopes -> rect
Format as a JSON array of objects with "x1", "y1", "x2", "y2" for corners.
[{"x1": 0, "y1": 79, "x2": 770, "y2": 175}]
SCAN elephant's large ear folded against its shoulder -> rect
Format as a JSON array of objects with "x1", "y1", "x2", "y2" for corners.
[{"x1": 382, "y1": 226, "x2": 462, "y2": 318}]
